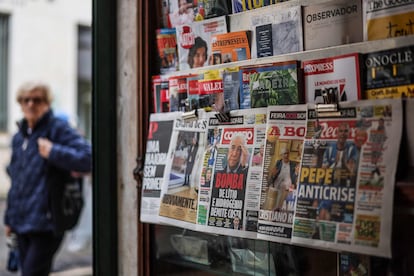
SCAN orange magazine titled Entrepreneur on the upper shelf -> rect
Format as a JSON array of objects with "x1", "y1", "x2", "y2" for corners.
[{"x1": 211, "y1": 31, "x2": 251, "y2": 65}]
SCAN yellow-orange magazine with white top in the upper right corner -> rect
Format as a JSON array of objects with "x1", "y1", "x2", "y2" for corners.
[{"x1": 362, "y1": 0, "x2": 414, "y2": 41}]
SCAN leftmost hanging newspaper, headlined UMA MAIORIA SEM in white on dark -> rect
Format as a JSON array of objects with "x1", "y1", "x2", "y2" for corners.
[{"x1": 140, "y1": 112, "x2": 181, "y2": 223}]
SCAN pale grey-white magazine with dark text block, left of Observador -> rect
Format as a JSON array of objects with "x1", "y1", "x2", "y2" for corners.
[{"x1": 250, "y1": 5, "x2": 303, "y2": 58}]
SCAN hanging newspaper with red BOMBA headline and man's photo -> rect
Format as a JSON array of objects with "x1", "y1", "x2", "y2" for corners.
[{"x1": 197, "y1": 108, "x2": 266, "y2": 238}]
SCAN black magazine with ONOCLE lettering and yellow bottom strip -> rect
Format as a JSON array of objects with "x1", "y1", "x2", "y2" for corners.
[{"x1": 362, "y1": 46, "x2": 414, "y2": 99}]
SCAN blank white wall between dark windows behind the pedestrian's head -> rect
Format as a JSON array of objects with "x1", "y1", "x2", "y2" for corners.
[{"x1": 0, "y1": 0, "x2": 92, "y2": 133}]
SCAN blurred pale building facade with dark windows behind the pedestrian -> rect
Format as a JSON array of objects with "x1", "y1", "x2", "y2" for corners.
[{"x1": 0, "y1": 0, "x2": 92, "y2": 195}]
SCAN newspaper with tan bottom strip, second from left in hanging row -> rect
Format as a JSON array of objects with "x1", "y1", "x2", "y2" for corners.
[{"x1": 159, "y1": 110, "x2": 207, "y2": 230}]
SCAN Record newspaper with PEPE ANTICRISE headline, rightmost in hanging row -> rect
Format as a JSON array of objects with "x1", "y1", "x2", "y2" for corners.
[{"x1": 292, "y1": 99, "x2": 402, "y2": 257}]
